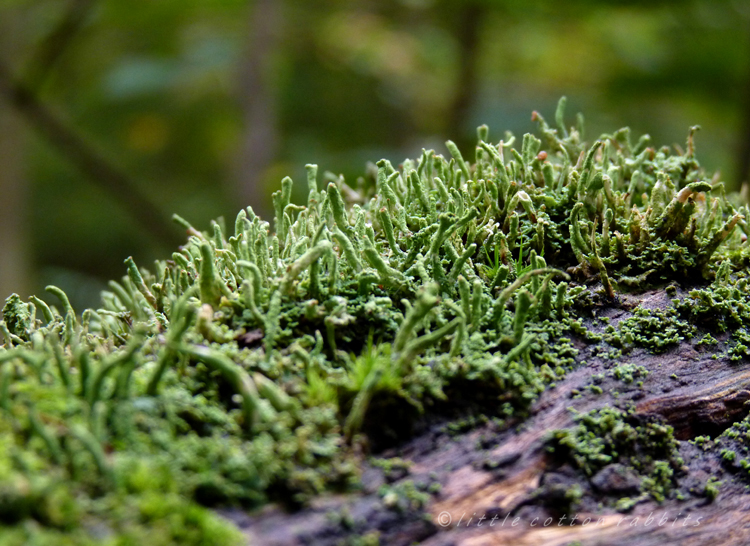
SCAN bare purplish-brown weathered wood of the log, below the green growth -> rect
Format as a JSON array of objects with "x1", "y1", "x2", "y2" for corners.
[{"x1": 224, "y1": 286, "x2": 750, "y2": 546}]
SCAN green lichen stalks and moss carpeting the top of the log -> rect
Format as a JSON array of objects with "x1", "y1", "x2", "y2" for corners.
[{"x1": 0, "y1": 99, "x2": 750, "y2": 544}]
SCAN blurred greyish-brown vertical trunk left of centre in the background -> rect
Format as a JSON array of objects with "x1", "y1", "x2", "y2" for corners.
[{"x1": 235, "y1": 0, "x2": 283, "y2": 223}]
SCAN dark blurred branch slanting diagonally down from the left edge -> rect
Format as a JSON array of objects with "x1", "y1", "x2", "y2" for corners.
[{"x1": 0, "y1": 62, "x2": 181, "y2": 247}]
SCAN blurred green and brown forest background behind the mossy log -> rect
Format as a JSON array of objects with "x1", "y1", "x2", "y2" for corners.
[{"x1": 0, "y1": 0, "x2": 750, "y2": 309}]
